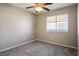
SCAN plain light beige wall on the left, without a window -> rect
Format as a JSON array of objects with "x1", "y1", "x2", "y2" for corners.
[{"x1": 0, "y1": 4, "x2": 34, "y2": 50}]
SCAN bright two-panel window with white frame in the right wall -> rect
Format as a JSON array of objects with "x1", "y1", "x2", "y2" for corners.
[{"x1": 47, "y1": 14, "x2": 68, "y2": 32}]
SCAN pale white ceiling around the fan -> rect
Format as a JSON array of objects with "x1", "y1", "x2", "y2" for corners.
[{"x1": 11, "y1": 3, "x2": 74, "y2": 13}]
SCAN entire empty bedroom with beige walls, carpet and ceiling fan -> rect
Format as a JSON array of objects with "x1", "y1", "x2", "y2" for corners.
[{"x1": 0, "y1": 3, "x2": 78, "y2": 56}]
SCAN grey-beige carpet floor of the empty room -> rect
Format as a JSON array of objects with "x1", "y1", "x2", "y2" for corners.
[{"x1": 0, "y1": 41, "x2": 77, "y2": 56}]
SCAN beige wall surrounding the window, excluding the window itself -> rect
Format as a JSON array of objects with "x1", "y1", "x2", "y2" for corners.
[{"x1": 36, "y1": 5, "x2": 77, "y2": 47}]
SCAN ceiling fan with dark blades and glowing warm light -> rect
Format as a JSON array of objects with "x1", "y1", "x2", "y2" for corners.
[{"x1": 25, "y1": 3, "x2": 53, "y2": 13}]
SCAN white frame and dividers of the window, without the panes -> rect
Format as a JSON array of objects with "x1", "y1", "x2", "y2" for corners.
[{"x1": 46, "y1": 14, "x2": 69, "y2": 32}]
